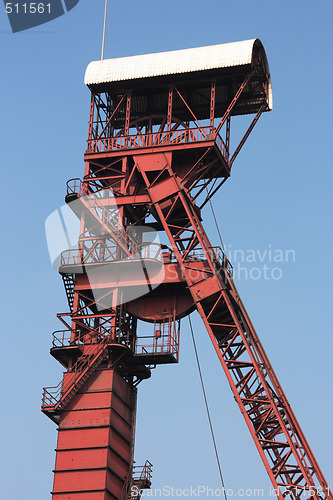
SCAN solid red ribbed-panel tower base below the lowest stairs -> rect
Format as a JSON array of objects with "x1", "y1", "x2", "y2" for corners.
[{"x1": 52, "y1": 369, "x2": 136, "y2": 500}]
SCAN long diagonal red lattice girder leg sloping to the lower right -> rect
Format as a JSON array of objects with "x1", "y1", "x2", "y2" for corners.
[{"x1": 136, "y1": 157, "x2": 332, "y2": 500}]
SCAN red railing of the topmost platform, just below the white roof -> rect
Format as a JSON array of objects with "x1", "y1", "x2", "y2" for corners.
[{"x1": 87, "y1": 127, "x2": 229, "y2": 159}]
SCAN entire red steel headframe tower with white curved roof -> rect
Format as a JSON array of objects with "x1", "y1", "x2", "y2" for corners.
[{"x1": 42, "y1": 40, "x2": 332, "y2": 500}]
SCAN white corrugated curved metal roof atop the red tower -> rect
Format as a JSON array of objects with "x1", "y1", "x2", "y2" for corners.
[{"x1": 84, "y1": 39, "x2": 256, "y2": 85}]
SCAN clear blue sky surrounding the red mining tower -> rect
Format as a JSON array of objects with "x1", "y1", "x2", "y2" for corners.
[{"x1": 0, "y1": 0, "x2": 333, "y2": 500}]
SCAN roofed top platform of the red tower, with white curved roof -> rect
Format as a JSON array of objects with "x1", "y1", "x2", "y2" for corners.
[{"x1": 84, "y1": 39, "x2": 272, "y2": 173}]
